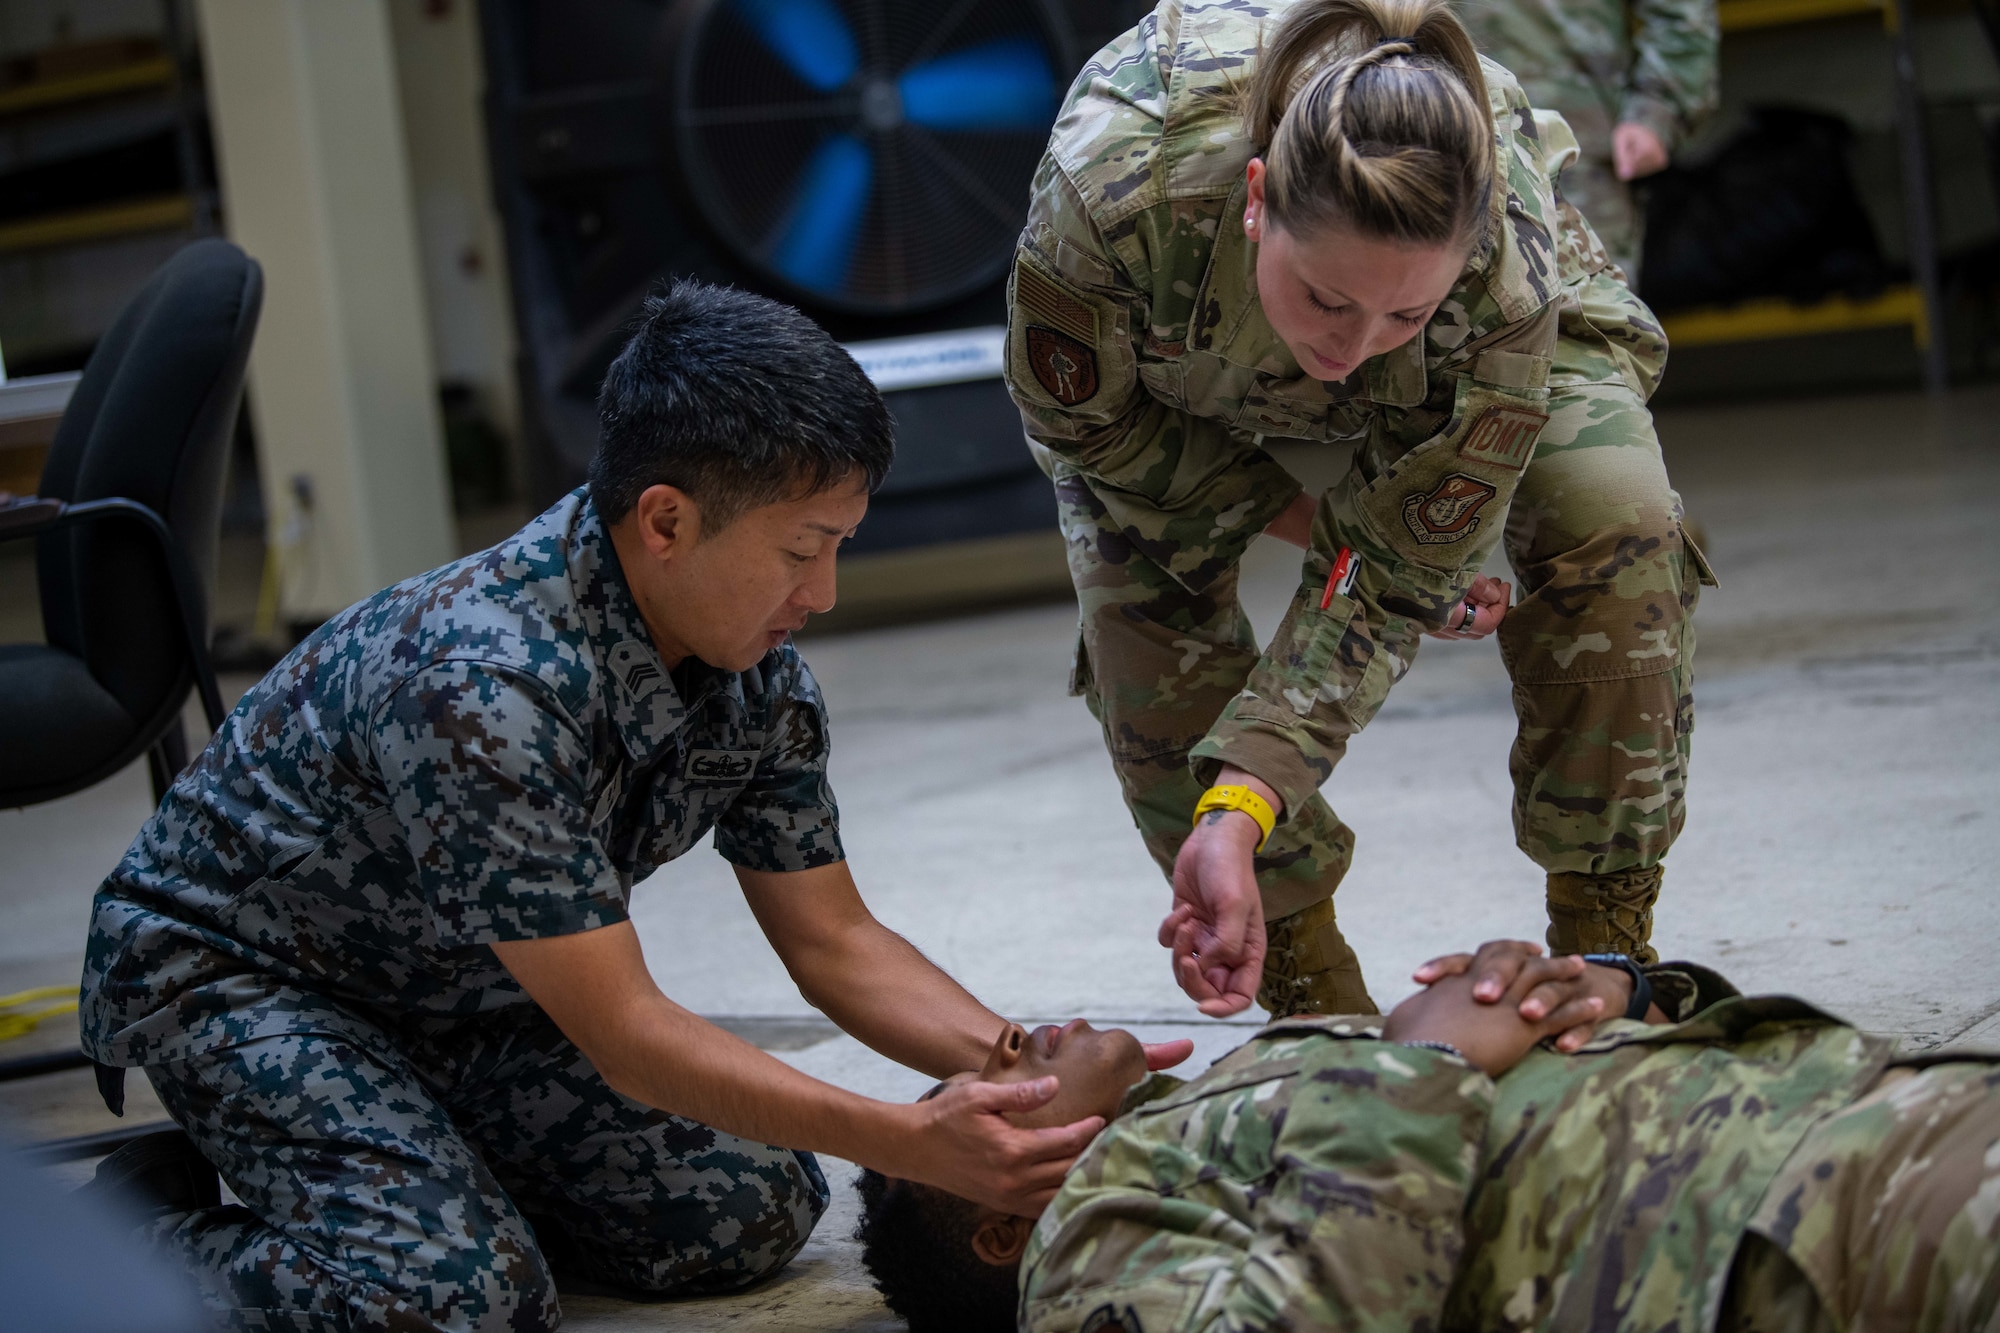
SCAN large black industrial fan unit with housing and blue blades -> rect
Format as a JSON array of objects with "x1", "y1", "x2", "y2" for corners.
[{"x1": 482, "y1": 0, "x2": 1146, "y2": 550}]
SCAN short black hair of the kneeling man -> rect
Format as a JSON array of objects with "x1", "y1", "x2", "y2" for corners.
[{"x1": 590, "y1": 280, "x2": 896, "y2": 534}]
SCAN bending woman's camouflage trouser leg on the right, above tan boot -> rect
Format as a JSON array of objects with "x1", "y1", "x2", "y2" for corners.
[{"x1": 1500, "y1": 384, "x2": 1700, "y2": 877}]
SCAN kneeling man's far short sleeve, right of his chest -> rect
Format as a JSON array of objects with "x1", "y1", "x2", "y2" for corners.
[{"x1": 716, "y1": 658, "x2": 846, "y2": 873}]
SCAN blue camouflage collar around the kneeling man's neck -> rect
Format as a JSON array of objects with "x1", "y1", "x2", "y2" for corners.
[{"x1": 570, "y1": 494, "x2": 736, "y2": 765}]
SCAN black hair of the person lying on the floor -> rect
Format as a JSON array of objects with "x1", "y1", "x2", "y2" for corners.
[{"x1": 854, "y1": 1171, "x2": 1020, "y2": 1333}]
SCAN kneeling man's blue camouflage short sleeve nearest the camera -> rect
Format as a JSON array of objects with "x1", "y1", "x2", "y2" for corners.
[{"x1": 370, "y1": 662, "x2": 626, "y2": 947}]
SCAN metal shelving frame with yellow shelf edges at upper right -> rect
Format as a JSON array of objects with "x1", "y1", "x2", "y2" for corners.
[{"x1": 1662, "y1": 0, "x2": 1946, "y2": 392}]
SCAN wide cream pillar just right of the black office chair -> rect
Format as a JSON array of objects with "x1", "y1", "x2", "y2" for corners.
[{"x1": 198, "y1": 0, "x2": 456, "y2": 618}]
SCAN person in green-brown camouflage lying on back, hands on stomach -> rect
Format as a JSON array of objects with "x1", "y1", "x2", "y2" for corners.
[{"x1": 858, "y1": 943, "x2": 2000, "y2": 1333}]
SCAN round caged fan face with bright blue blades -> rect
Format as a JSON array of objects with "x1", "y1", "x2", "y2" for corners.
[{"x1": 668, "y1": 0, "x2": 1066, "y2": 314}]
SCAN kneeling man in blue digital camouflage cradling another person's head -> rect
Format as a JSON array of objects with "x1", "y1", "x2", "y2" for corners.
[{"x1": 82, "y1": 284, "x2": 1174, "y2": 1329}]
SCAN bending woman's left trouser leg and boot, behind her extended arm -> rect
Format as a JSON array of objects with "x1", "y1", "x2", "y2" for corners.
[{"x1": 1056, "y1": 468, "x2": 1374, "y2": 1013}]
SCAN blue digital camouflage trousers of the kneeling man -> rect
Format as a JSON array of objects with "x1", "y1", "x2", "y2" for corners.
[{"x1": 148, "y1": 1011, "x2": 828, "y2": 1333}]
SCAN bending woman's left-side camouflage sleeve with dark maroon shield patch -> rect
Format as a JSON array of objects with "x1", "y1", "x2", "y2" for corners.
[{"x1": 1006, "y1": 156, "x2": 1300, "y2": 590}]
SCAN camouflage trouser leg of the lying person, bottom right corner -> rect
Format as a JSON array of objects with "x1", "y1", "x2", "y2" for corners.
[{"x1": 1716, "y1": 1061, "x2": 2000, "y2": 1333}]
